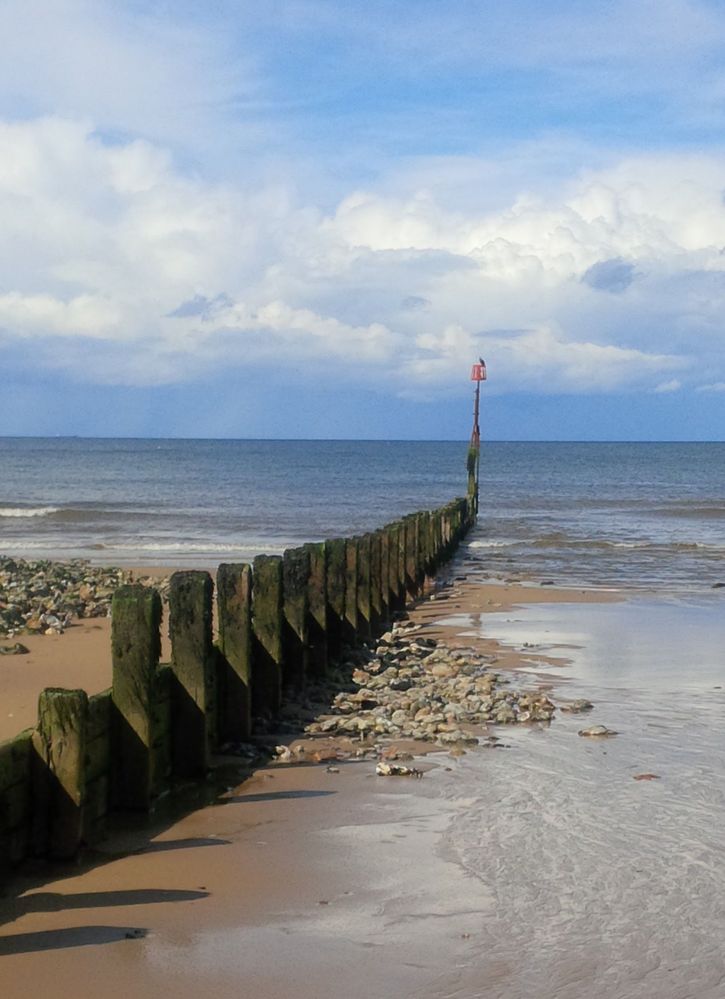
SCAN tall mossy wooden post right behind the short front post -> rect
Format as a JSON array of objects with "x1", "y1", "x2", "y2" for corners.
[{"x1": 111, "y1": 583, "x2": 161, "y2": 811}]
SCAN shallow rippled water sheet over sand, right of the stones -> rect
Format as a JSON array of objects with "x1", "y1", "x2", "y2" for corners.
[{"x1": 432, "y1": 597, "x2": 725, "y2": 999}]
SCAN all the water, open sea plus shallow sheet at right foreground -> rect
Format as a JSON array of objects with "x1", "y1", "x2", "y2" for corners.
[{"x1": 0, "y1": 439, "x2": 725, "y2": 999}]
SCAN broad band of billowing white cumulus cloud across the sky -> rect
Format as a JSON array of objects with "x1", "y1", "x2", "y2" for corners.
[{"x1": 0, "y1": 118, "x2": 725, "y2": 393}]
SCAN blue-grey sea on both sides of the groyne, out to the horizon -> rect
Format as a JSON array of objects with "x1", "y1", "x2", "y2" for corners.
[{"x1": 0, "y1": 438, "x2": 725, "y2": 588}]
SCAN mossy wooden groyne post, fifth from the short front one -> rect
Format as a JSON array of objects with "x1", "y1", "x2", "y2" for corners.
[{"x1": 252, "y1": 555, "x2": 283, "y2": 718}]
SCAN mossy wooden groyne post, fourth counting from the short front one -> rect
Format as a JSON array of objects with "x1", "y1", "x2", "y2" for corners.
[{"x1": 216, "y1": 562, "x2": 252, "y2": 743}]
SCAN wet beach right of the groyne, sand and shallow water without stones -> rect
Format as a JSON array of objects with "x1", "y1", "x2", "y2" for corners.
[{"x1": 0, "y1": 564, "x2": 725, "y2": 999}]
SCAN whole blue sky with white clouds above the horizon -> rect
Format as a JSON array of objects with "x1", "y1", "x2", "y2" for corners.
[{"x1": 0, "y1": 0, "x2": 725, "y2": 440}]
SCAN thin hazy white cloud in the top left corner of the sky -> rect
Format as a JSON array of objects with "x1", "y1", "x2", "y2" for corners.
[{"x1": 0, "y1": 0, "x2": 258, "y2": 148}]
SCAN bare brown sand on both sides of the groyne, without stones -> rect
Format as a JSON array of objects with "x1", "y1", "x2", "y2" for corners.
[{"x1": 0, "y1": 584, "x2": 613, "y2": 999}]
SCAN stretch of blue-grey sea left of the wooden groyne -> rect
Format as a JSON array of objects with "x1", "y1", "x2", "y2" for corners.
[{"x1": 0, "y1": 438, "x2": 467, "y2": 567}]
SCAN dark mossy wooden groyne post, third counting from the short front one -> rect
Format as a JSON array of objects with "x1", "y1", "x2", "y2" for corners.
[{"x1": 169, "y1": 570, "x2": 216, "y2": 777}]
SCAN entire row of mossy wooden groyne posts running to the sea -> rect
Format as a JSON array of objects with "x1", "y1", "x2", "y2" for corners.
[{"x1": 0, "y1": 499, "x2": 473, "y2": 869}]
